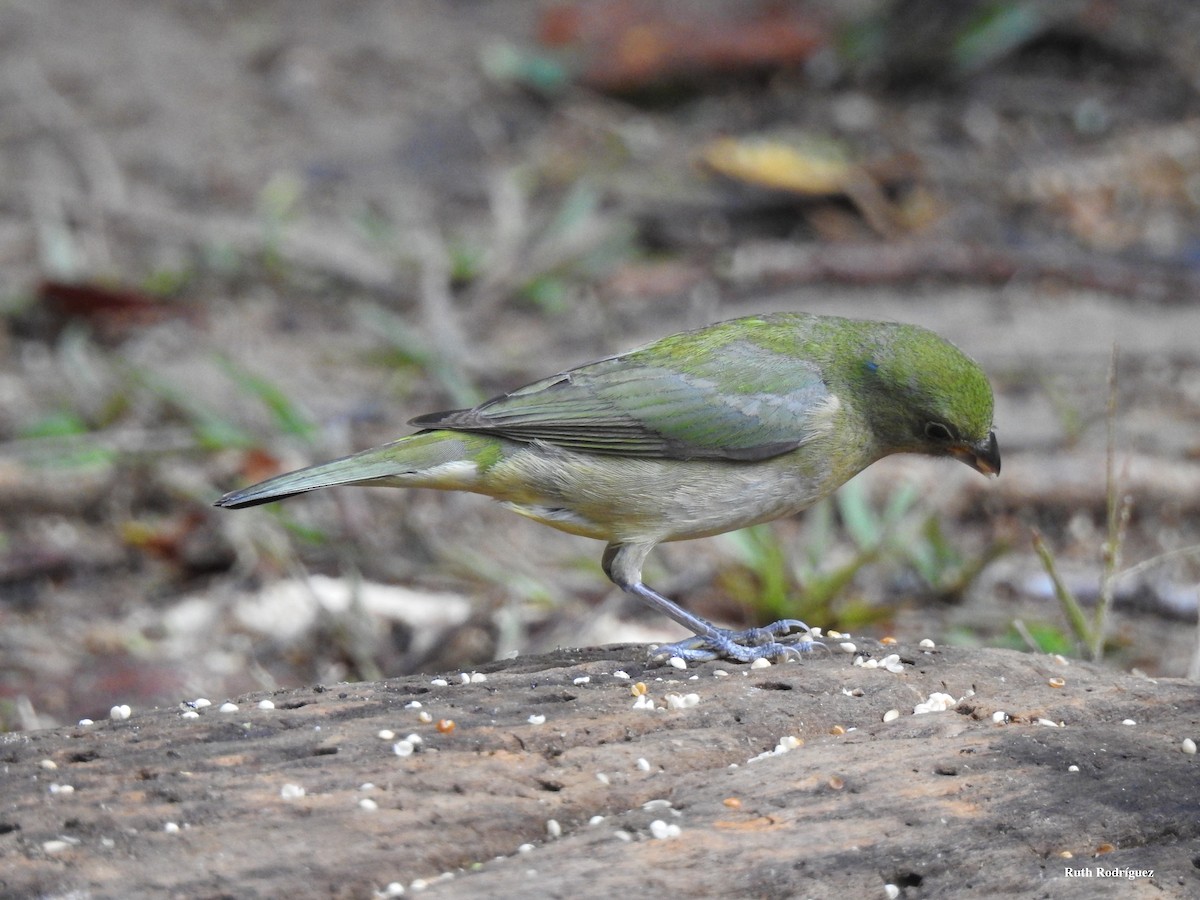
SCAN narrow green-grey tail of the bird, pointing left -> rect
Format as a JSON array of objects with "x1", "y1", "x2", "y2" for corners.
[{"x1": 216, "y1": 431, "x2": 502, "y2": 509}]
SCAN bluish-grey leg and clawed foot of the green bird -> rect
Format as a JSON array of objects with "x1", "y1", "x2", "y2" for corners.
[{"x1": 602, "y1": 544, "x2": 814, "y2": 662}]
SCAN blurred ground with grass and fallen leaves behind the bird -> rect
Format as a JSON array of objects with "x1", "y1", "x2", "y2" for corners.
[{"x1": 0, "y1": 0, "x2": 1200, "y2": 730}]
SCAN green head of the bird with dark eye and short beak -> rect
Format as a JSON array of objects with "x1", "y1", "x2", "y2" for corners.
[{"x1": 857, "y1": 325, "x2": 1000, "y2": 475}]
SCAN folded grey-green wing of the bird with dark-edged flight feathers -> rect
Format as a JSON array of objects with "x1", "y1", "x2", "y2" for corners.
[{"x1": 410, "y1": 336, "x2": 835, "y2": 460}]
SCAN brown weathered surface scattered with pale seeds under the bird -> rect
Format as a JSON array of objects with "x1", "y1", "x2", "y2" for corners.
[{"x1": 0, "y1": 646, "x2": 1200, "y2": 898}]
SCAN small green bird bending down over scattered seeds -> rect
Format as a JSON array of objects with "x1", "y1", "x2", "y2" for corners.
[{"x1": 217, "y1": 313, "x2": 1000, "y2": 661}]
